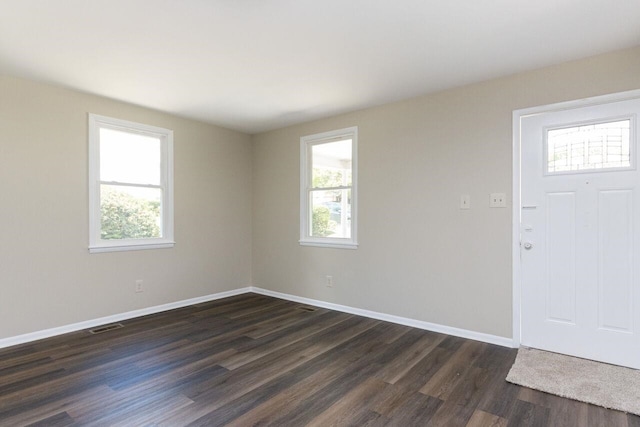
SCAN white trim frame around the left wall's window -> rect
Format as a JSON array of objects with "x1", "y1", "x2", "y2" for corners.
[{"x1": 89, "y1": 113, "x2": 175, "y2": 253}]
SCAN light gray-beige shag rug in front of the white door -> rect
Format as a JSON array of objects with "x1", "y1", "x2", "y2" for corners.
[{"x1": 507, "y1": 347, "x2": 640, "y2": 415}]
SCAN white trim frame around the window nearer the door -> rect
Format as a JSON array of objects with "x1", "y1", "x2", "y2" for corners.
[{"x1": 299, "y1": 126, "x2": 358, "y2": 249}]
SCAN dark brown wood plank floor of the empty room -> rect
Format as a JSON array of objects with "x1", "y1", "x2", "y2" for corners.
[{"x1": 0, "y1": 294, "x2": 640, "y2": 426}]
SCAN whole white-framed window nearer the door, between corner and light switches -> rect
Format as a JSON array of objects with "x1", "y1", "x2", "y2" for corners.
[{"x1": 300, "y1": 127, "x2": 358, "y2": 249}]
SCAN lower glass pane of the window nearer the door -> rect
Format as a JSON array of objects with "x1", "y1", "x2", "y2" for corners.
[{"x1": 310, "y1": 190, "x2": 351, "y2": 238}]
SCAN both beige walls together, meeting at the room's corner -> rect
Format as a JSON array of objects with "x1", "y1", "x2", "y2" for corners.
[{"x1": 5, "y1": 48, "x2": 640, "y2": 339}]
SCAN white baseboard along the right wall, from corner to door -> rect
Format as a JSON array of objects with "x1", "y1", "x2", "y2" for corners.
[{"x1": 251, "y1": 286, "x2": 514, "y2": 348}]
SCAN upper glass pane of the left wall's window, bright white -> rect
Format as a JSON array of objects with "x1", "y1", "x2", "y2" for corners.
[{"x1": 100, "y1": 128, "x2": 162, "y2": 185}]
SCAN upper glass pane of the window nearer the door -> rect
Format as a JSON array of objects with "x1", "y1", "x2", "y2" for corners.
[{"x1": 311, "y1": 139, "x2": 351, "y2": 188}]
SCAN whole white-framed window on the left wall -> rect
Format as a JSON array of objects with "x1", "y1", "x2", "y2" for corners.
[{"x1": 89, "y1": 114, "x2": 174, "y2": 252}]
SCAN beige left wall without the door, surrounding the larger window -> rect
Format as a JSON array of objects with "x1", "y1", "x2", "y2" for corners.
[{"x1": 0, "y1": 76, "x2": 251, "y2": 339}]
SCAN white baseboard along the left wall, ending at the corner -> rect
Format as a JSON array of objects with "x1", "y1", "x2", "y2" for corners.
[{"x1": 0, "y1": 287, "x2": 251, "y2": 348}]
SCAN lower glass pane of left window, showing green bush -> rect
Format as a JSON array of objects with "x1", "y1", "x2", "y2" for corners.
[{"x1": 100, "y1": 184, "x2": 162, "y2": 240}]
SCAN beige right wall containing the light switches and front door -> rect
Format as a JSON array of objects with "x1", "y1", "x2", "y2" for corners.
[{"x1": 252, "y1": 48, "x2": 640, "y2": 337}]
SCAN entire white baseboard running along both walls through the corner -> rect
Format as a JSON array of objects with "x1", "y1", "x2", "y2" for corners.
[{"x1": 0, "y1": 286, "x2": 517, "y2": 349}]
